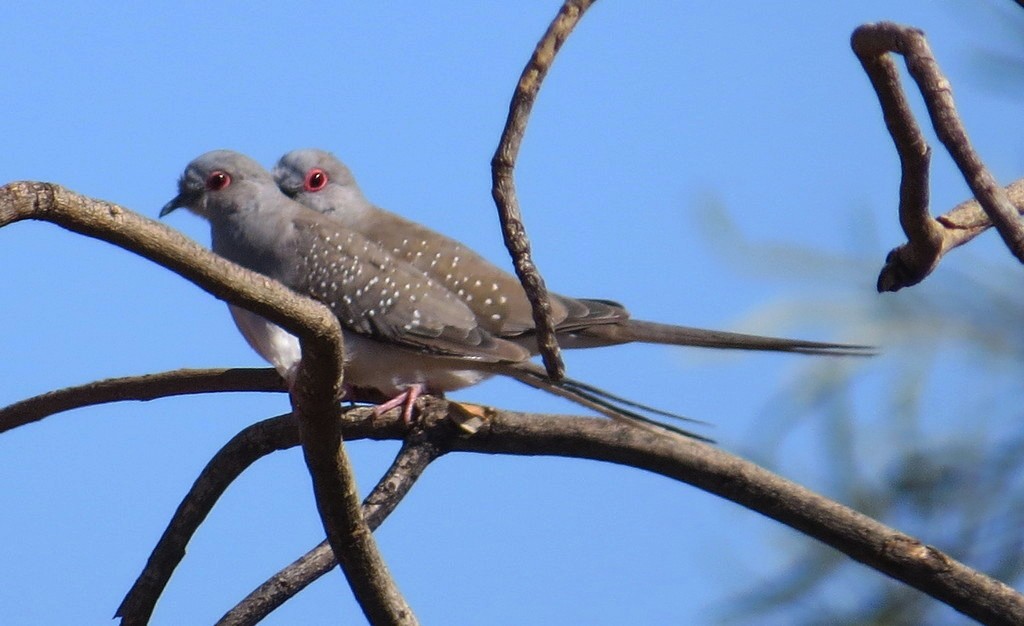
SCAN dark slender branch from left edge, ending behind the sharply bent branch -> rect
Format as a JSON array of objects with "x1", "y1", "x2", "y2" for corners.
[{"x1": 0, "y1": 368, "x2": 288, "y2": 433}]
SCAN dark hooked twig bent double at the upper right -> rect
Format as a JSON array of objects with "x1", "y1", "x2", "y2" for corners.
[{"x1": 851, "y1": 23, "x2": 1024, "y2": 291}]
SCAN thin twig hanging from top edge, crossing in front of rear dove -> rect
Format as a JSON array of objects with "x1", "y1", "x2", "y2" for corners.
[{"x1": 490, "y1": 0, "x2": 594, "y2": 380}]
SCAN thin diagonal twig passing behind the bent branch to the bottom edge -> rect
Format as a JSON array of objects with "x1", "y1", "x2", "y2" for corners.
[{"x1": 217, "y1": 424, "x2": 453, "y2": 626}]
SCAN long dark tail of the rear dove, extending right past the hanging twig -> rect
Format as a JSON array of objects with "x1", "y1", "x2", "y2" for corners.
[{"x1": 558, "y1": 320, "x2": 878, "y2": 357}]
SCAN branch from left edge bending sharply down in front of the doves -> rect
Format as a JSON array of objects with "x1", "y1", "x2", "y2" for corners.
[{"x1": 0, "y1": 182, "x2": 416, "y2": 624}]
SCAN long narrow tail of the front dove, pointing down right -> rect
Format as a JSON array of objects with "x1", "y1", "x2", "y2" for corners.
[{"x1": 501, "y1": 363, "x2": 714, "y2": 443}]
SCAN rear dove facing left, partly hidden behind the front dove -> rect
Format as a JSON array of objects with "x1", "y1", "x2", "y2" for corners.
[{"x1": 273, "y1": 149, "x2": 870, "y2": 354}]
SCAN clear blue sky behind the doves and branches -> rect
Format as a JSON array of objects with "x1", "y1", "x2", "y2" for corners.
[{"x1": 0, "y1": 0, "x2": 1024, "y2": 624}]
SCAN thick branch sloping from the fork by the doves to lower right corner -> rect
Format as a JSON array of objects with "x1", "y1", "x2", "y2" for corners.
[{"x1": 462, "y1": 412, "x2": 1024, "y2": 626}]
